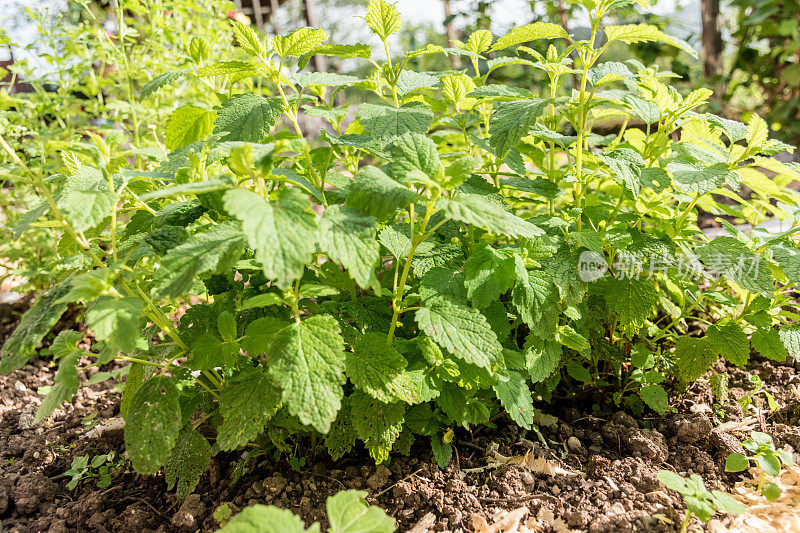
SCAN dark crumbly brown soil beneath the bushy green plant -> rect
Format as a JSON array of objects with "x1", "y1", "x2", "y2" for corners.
[{"x1": 0, "y1": 294, "x2": 800, "y2": 532}]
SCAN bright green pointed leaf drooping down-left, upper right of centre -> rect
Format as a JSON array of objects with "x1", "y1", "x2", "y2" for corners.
[{"x1": 489, "y1": 98, "x2": 549, "y2": 159}]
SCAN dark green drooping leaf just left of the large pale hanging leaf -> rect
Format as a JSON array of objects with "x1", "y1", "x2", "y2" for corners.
[{"x1": 217, "y1": 366, "x2": 280, "y2": 451}]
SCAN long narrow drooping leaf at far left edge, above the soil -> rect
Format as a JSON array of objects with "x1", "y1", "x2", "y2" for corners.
[{"x1": 0, "y1": 281, "x2": 70, "y2": 374}]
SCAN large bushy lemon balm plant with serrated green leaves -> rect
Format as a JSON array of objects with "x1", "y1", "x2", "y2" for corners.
[{"x1": 0, "y1": 0, "x2": 800, "y2": 495}]
